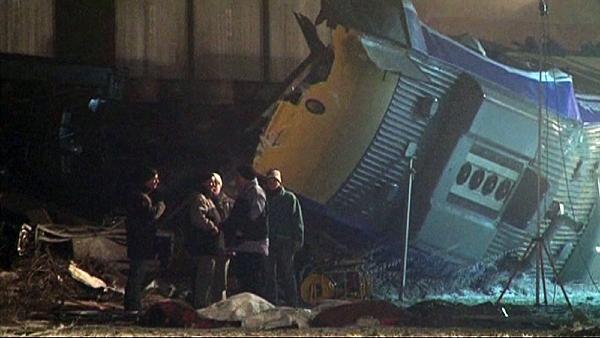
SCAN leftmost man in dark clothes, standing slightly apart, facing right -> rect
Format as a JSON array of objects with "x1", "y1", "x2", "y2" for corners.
[{"x1": 124, "y1": 168, "x2": 165, "y2": 311}]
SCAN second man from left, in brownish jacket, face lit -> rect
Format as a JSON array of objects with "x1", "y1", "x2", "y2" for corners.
[{"x1": 186, "y1": 173, "x2": 232, "y2": 309}]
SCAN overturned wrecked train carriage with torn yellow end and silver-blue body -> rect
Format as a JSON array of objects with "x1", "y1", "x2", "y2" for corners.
[{"x1": 254, "y1": 0, "x2": 600, "y2": 280}]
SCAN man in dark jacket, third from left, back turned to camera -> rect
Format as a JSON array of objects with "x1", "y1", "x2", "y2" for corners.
[{"x1": 224, "y1": 165, "x2": 269, "y2": 296}]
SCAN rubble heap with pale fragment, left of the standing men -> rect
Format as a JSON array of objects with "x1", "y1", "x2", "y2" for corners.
[{"x1": 0, "y1": 219, "x2": 126, "y2": 324}]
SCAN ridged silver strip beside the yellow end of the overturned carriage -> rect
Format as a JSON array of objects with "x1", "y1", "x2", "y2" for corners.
[{"x1": 327, "y1": 55, "x2": 458, "y2": 228}]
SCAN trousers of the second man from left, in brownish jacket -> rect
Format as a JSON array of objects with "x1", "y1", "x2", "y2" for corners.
[{"x1": 192, "y1": 255, "x2": 229, "y2": 309}]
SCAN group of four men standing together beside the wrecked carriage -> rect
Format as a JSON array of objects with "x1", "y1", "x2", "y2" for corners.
[{"x1": 124, "y1": 165, "x2": 304, "y2": 311}]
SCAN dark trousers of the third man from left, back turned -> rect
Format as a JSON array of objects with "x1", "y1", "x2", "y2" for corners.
[{"x1": 235, "y1": 252, "x2": 266, "y2": 297}]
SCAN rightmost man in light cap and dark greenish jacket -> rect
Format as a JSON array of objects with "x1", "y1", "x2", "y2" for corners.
[{"x1": 267, "y1": 169, "x2": 304, "y2": 307}]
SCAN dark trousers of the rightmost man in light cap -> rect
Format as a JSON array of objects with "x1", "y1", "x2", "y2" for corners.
[{"x1": 266, "y1": 241, "x2": 298, "y2": 307}]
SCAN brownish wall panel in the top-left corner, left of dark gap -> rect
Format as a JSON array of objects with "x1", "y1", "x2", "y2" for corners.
[{"x1": 0, "y1": 0, "x2": 54, "y2": 56}]
